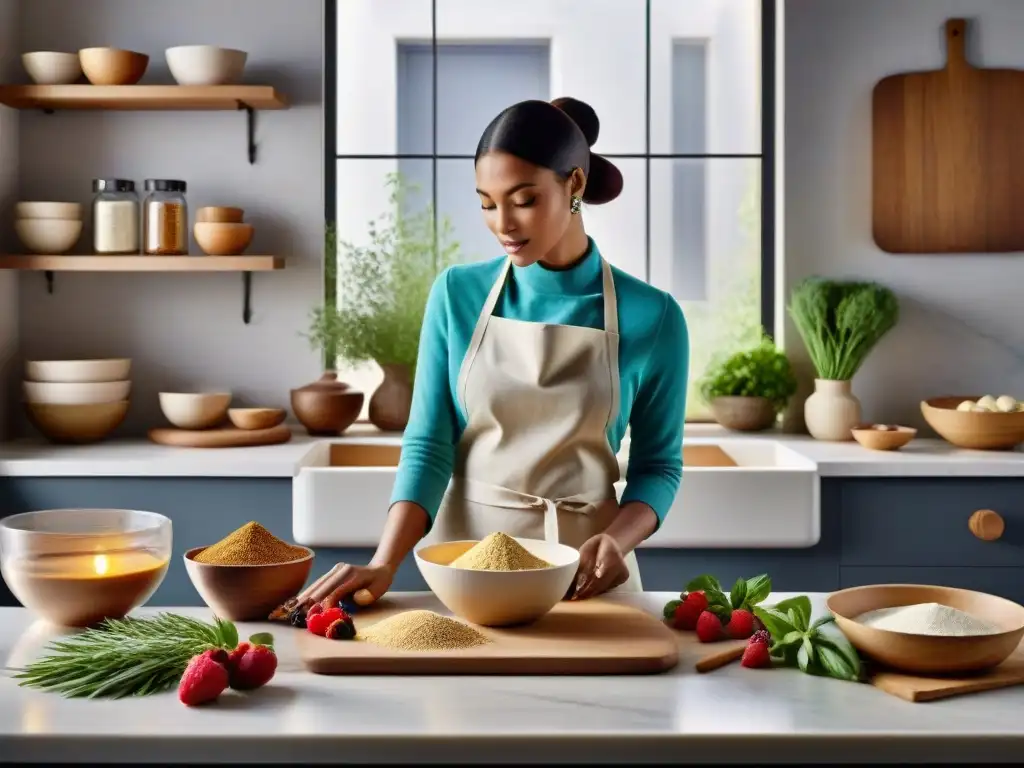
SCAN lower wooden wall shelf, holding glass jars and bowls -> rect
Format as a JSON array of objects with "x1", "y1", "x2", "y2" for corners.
[{"x1": 0, "y1": 255, "x2": 285, "y2": 272}]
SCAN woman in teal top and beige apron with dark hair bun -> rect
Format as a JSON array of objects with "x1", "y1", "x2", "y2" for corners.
[{"x1": 310, "y1": 98, "x2": 688, "y2": 604}]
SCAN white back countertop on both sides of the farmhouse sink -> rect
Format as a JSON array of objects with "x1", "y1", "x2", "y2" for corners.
[{"x1": 0, "y1": 424, "x2": 1024, "y2": 477}]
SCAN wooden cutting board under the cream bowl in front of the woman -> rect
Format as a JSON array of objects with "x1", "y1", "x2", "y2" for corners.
[{"x1": 296, "y1": 593, "x2": 679, "y2": 675}]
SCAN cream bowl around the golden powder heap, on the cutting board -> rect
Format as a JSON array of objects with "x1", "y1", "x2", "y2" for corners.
[{"x1": 415, "y1": 538, "x2": 580, "y2": 627}]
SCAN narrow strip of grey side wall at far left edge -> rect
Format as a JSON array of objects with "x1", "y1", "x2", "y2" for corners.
[{"x1": 0, "y1": 0, "x2": 20, "y2": 439}]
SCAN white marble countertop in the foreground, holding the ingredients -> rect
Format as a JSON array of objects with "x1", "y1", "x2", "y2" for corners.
[{"x1": 0, "y1": 593, "x2": 1024, "y2": 764}]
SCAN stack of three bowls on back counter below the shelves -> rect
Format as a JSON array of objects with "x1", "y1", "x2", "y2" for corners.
[{"x1": 23, "y1": 358, "x2": 131, "y2": 443}]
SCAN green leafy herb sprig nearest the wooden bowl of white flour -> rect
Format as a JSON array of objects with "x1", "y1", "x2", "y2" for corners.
[{"x1": 754, "y1": 595, "x2": 864, "y2": 682}]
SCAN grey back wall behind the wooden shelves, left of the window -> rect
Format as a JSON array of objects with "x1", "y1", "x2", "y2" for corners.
[{"x1": 12, "y1": 0, "x2": 324, "y2": 433}]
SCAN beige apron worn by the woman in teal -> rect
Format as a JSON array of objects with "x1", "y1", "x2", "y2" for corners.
[{"x1": 428, "y1": 252, "x2": 642, "y2": 592}]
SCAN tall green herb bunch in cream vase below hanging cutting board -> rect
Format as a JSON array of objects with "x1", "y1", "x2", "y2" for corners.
[{"x1": 788, "y1": 278, "x2": 899, "y2": 440}]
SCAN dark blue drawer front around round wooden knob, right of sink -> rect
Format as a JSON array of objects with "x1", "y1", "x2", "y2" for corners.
[{"x1": 839, "y1": 477, "x2": 1024, "y2": 566}]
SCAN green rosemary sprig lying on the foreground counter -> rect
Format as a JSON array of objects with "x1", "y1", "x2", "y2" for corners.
[{"x1": 14, "y1": 613, "x2": 239, "y2": 698}]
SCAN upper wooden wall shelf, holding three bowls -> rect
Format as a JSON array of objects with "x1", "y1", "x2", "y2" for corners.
[{"x1": 0, "y1": 85, "x2": 288, "y2": 111}]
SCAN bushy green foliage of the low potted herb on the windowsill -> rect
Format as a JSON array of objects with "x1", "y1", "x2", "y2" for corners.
[{"x1": 700, "y1": 333, "x2": 797, "y2": 413}]
